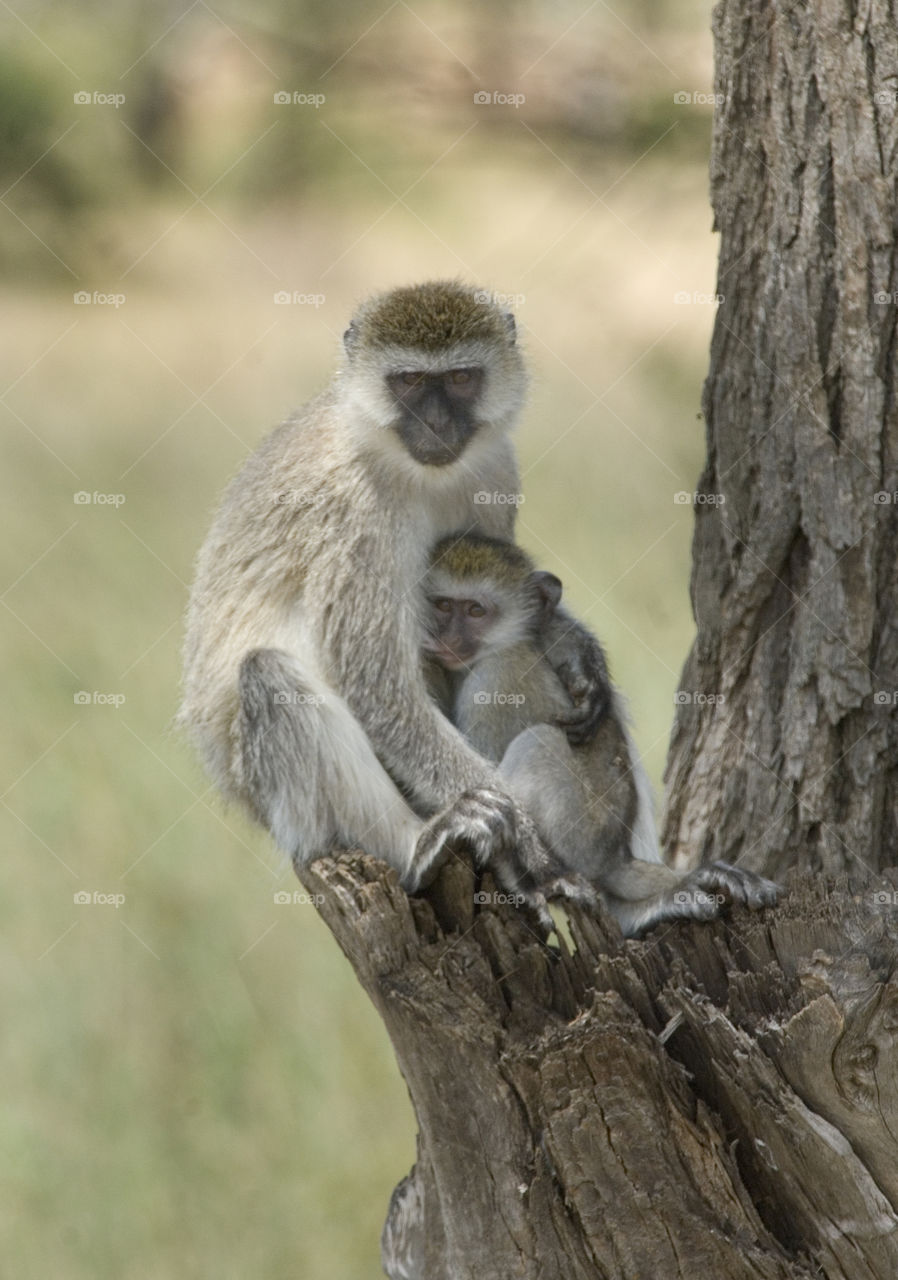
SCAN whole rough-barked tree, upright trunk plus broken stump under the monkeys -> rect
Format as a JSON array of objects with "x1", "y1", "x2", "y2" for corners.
[{"x1": 303, "y1": 0, "x2": 898, "y2": 1280}]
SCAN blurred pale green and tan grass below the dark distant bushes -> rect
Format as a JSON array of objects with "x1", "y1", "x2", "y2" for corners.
[{"x1": 0, "y1": 5, "x2": 715, "y2": 1280}]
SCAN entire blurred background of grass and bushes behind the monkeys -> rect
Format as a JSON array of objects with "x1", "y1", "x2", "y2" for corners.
[{"x1": 0, "y1": 0, "x2": 715, "y2": 1280}]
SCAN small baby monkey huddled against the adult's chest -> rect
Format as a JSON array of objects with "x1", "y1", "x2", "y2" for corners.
[{"x1": 423, "y1": 534, "x2": 776, "y2": 936}]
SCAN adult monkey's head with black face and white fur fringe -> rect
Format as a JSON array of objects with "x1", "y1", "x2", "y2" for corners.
[{"x1": 340, "y1": 280, "x2": 526, "y2": 468}]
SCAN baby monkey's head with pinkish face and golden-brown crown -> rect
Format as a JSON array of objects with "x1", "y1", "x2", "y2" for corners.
[{"x1": 423, "y1": 534, "x2": 562, "y2": 671}]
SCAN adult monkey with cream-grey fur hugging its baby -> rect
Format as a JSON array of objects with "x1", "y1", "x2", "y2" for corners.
[{"x1": 180, "y1": 282, "x2": 610, "y2": 890}]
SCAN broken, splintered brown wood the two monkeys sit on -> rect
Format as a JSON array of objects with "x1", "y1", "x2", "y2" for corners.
[{"x1": 303, "y1": 855, "x2": 898, "y2": 1280}]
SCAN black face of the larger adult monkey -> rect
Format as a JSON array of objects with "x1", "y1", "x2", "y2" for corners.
[{"x1": 386, "y1": 366, "x2": 484, "y2": 467}]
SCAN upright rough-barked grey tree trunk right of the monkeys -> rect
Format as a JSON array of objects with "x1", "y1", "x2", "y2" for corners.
[{"x1": 665, "y1": 0, "x2": 898, "y2": 878}]
